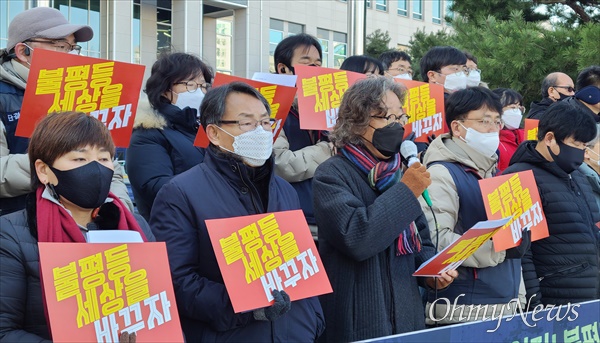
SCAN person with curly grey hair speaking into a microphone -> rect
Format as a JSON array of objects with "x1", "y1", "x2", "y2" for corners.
[{"x1": 314, "y1": 77, "x2": 456, "y2": 342}]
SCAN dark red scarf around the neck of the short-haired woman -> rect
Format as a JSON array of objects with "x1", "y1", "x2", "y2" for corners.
[{"x1": 36, "y1": 187, "x2": 147, "y2": 243}]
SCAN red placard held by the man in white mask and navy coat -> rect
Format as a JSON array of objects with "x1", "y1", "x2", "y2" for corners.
[{"x1": 206, "y1": 210, "x2": 332, "y2": 313}]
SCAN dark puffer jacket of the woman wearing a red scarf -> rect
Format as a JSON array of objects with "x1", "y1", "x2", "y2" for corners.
[{"x1": 0, "y1": 201, "x2": 155, "y2": 342}]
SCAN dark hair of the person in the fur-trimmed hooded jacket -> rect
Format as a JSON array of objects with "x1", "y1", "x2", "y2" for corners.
[{"x1": 144, "y1": 52, "x2": 213, "y2": 109}]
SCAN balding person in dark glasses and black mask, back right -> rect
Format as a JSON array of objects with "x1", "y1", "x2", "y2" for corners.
[{"x1": 528, "y1": 72, "x2": 575, "y2": 119}]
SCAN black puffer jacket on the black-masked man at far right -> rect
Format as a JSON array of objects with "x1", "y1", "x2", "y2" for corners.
[{"x1": 504, "y1": 141, "x2": 600, "y2": 304}]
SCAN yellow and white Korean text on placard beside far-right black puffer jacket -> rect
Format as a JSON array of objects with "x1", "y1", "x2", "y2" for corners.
[{"x1": 488, "y1": 174, "x2": 543, "y2": 243}]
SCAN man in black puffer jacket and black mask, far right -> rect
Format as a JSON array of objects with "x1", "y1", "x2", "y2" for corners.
[{"x1": 504, "y1": 102, "x2": 600, "y2": 305}]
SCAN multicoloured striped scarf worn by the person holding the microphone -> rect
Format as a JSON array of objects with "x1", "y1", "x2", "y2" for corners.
[{"x1": 340, "y1": 144, "x2": 421, "y2": 255}]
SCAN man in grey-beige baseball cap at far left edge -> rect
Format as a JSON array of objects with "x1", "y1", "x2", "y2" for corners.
[{"x1": 0, "y1": 7, "x2": 133, "y2": 214}]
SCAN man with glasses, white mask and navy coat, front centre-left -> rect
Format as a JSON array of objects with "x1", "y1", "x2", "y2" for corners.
[{"x1": 150, "y1": 82, "x2": 324, "y2": 342}]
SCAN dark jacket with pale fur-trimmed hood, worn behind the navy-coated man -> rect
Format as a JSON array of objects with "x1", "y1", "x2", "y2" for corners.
[{"x1": 125, "y1": 102, "x2": 204, "y2": 220}]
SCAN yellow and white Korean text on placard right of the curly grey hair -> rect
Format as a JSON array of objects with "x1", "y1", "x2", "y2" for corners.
[{"x1": 406, "y1": 84, "x2": 443, "y2": 137}]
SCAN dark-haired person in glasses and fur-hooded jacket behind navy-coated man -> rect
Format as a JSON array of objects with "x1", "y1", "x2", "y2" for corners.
[{"x1": 125, "y1": 52, "x2": 213, "y2": 220}]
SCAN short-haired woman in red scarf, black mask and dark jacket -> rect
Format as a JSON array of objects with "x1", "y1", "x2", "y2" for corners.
[{"x1": 0, "y1": 112, "x2": 154, "y2": 342}]
